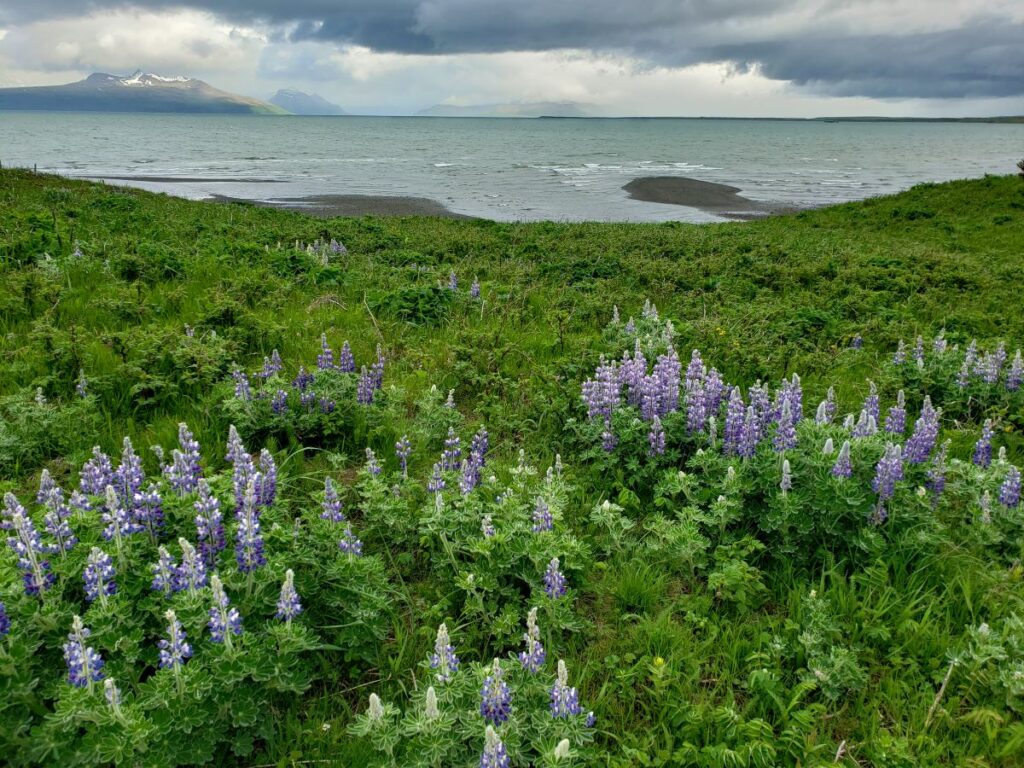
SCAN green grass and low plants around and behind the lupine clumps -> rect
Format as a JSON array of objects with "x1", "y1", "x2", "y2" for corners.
[{"x1": 0, "y1": 170, "x2": 1024, "y2": 766}]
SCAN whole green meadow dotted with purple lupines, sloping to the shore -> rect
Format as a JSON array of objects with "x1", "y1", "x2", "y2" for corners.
[{"x1": 0, "y1": 170, "x2": 1024, "y2": 768}]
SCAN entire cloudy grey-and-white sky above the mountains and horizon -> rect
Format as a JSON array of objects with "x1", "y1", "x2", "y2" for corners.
[{"x1": 0, "y1": 0, "x2": 1024, "y2": 117}]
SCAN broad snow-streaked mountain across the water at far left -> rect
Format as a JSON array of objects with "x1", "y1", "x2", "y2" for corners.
[{"x1": 0, "y1": 71, "x2": 288, "y2": 115}]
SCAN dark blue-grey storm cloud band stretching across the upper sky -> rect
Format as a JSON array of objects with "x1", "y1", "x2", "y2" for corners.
[{"x1": 0, "y1": 0, "x2": 1024, "y2": 97}]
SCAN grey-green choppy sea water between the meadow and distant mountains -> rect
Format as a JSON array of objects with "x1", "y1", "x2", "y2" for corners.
[{"x1": 0, "y1": 113, "x2": 1024, "y2": 221}]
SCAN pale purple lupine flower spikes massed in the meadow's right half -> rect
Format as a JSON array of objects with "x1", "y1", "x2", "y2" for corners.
[{"x1": 583, "y1": 311, "x2": 1022, "y2": 522}]
